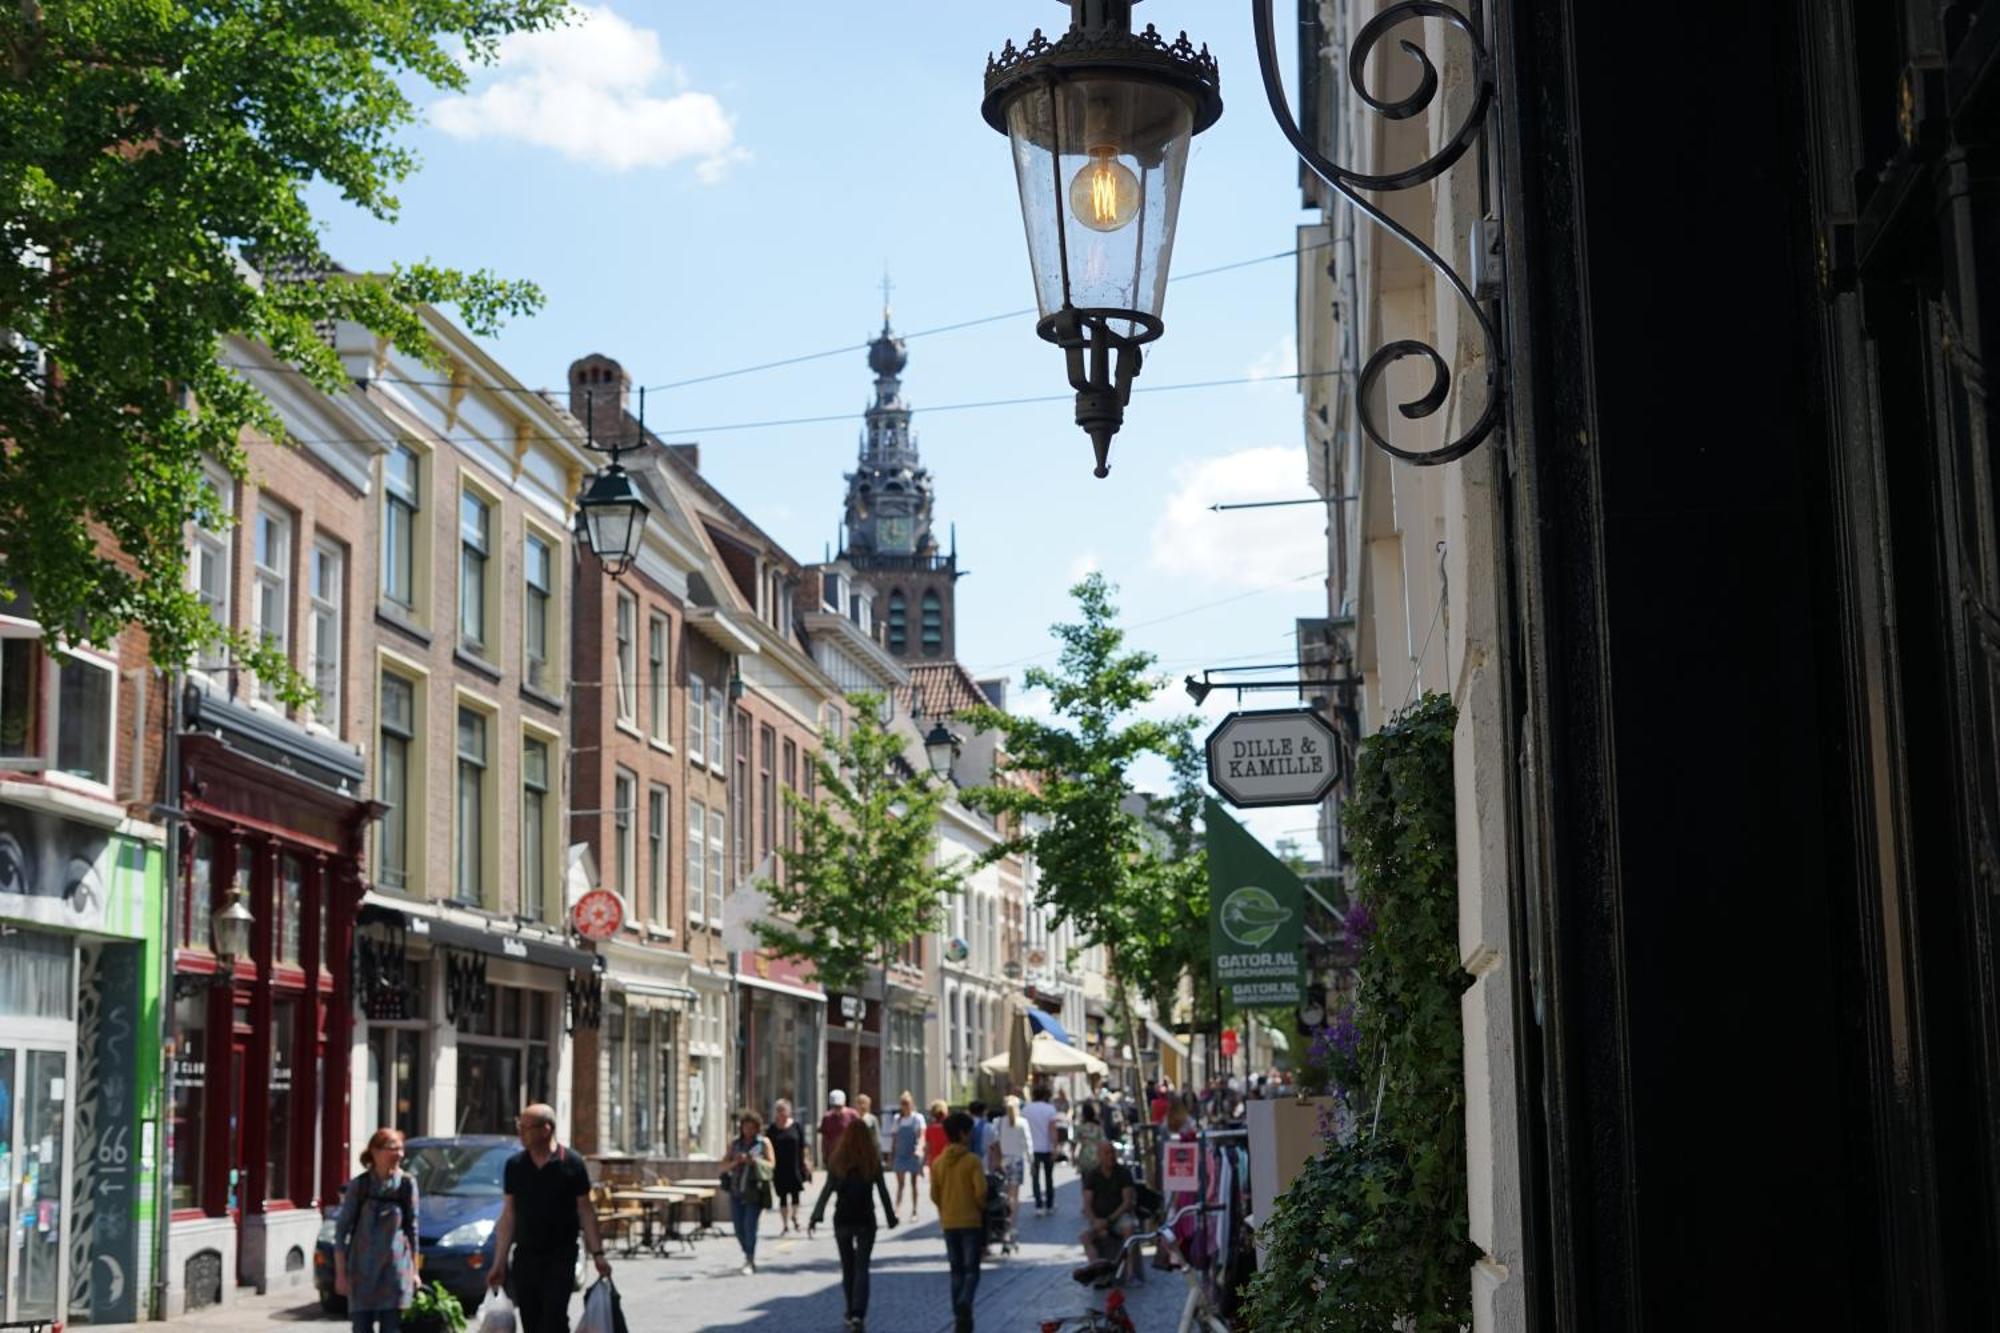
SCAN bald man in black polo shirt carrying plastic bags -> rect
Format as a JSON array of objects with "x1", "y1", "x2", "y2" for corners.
[{"x1": 486, "y1": 1105, "x2": 612, "y2": 1333}]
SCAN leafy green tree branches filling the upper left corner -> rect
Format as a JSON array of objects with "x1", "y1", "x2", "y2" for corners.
[{"x1": 0, "y1": 0, "x2": 568, "y2": 684}]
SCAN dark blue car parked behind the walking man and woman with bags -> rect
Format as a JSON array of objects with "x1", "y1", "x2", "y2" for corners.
[{"x1": 312, "y1": 1135, "x2": 560, "y2": 1315}]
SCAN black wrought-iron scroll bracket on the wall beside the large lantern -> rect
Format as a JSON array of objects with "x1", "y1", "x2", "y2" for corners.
[{"x1": 1250, "y1": 0, "x2": 1502, "y2": 466}]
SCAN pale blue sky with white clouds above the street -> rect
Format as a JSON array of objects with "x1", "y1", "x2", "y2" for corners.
[{"x1": 316, "y1": 0, "x2": 1324, "y2": 845}]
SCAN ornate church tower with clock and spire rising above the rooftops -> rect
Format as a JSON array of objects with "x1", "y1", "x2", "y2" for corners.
[{"x1": 840, "y1": 296, "x2": 958, "y2": 662}]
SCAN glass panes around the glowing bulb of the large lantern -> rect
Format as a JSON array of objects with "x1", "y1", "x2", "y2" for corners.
[{"x1": 1008, "y1": 78, "x2": 1194, "y2": 334}]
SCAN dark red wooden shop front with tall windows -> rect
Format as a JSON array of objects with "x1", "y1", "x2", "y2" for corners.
[{"x1": 168, "y1": 689, "x2": 376, "y2": 1311}]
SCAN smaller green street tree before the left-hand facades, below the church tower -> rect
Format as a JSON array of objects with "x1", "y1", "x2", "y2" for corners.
[{"x1": 752, "y1": 695, "x2": 962, "y2": 1073}]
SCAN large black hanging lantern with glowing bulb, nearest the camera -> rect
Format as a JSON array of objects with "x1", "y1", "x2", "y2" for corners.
[{"x1": 980, "y1": 0, "x2": 1222, "y2": 476}]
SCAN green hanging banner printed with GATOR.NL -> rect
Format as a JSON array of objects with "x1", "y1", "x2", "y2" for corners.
[{"x1": 1206, "y1": 801, "x2": 1306, "y2": 1009}]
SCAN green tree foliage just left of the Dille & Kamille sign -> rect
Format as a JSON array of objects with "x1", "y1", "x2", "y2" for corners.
[{"x1": 964, "y1": 572, "x2": 1208, "y2": 1012}]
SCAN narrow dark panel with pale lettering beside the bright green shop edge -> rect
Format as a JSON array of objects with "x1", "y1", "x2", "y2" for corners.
[{"x1": 90, "y1": 945, "x2": 140, "y2": 1323}]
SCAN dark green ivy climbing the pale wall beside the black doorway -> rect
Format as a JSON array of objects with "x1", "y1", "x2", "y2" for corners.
[{"x1": 1246, "y1": 695, "x2": 1478, "y2": 1333}]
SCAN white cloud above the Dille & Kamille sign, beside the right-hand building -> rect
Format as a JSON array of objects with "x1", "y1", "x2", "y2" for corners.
[{"x1": 1150, "y1": 448, "x2": 1326, "y2": 588}]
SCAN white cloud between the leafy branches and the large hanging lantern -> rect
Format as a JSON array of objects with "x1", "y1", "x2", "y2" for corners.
[{"x1": 430, "y1": 6, "x2": 750, "y2": 184}]
